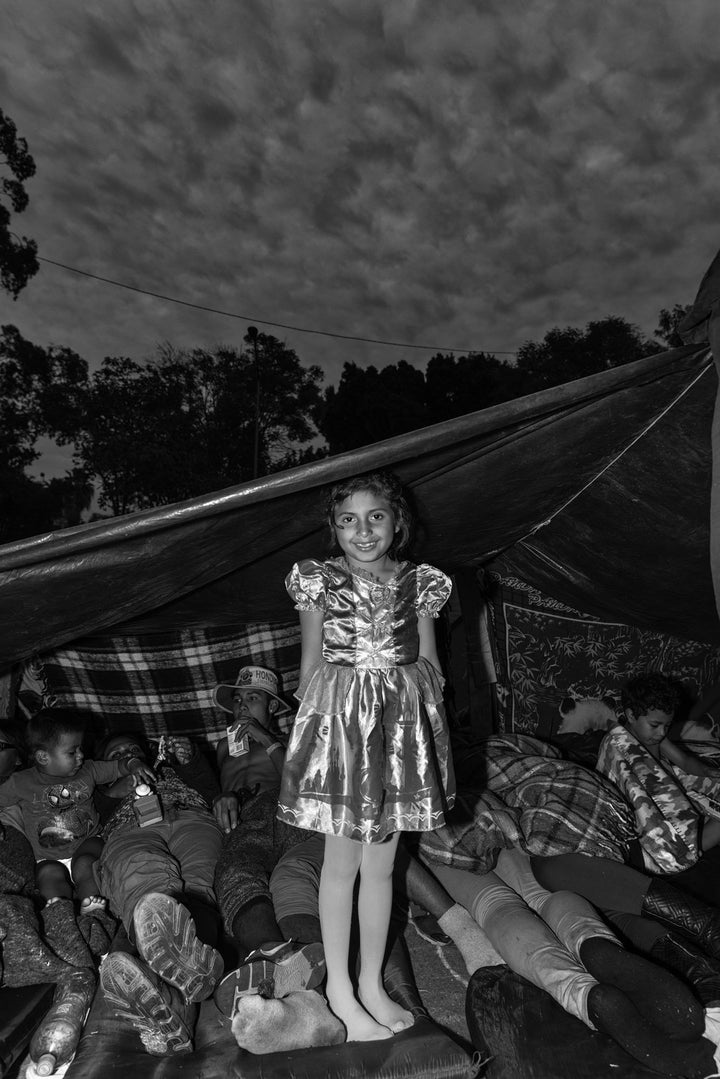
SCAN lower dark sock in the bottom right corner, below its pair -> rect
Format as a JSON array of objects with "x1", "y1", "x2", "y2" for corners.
[{"x1": 587, "y1": 985, "x2": 715, "y2": 1079}]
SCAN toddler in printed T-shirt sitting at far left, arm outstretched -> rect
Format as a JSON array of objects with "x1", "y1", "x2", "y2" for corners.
[{"x1": 0, "y1": 708, "x2": 152, "y2": 913}]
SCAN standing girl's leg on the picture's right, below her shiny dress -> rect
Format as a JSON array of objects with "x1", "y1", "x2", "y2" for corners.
[{"x1": 357, "y1": 832, "x2": 413, "y2": 1034}]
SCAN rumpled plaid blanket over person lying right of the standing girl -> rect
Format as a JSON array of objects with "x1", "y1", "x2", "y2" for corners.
[{"x1": 420, "y1": 735, "x2": 636, "y2": 873}]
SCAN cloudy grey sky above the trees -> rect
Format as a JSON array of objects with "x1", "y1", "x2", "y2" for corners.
[{"x1": 0, "y1": 0, "x2": 720, "y2": 476}]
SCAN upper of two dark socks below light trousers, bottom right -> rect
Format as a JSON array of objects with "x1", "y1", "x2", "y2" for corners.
[{"x1": 580, "y1": 937, "x2": 705, "y2": 1039}]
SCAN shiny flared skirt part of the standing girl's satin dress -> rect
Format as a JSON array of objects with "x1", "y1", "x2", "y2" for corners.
[{"x1": 277, "y1": 658, "x2": 454, "y2": 843}]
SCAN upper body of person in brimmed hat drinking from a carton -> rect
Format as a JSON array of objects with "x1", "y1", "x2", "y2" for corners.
[{"x1": 213, "y1": 667, "x2": 289, "y2": 832}]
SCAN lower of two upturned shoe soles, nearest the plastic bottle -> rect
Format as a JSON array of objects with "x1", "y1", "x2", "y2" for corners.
[{"x1": 100, "y1": 952, "x2": 192, "y2": 1056}]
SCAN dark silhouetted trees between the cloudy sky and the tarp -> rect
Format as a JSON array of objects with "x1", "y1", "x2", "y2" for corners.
[{"x1": 0, "y1": 110, "x2": 687, "y2": 543}]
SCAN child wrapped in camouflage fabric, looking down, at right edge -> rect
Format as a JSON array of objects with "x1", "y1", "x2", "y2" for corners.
[{"x1": 597, "y1": 673, "x2": 720, "y2": 873}]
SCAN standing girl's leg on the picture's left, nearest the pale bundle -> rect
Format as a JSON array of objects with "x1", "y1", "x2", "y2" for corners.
[{"x1": 318, "y1": 835, "x2": 392, "y2": 1041}]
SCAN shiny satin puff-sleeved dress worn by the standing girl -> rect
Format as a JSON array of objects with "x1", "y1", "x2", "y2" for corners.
[{"x1": 277, "y1": 558, "x2": 454, "y2": 843}]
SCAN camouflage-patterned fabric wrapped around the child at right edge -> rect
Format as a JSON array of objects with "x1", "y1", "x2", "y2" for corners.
[{"x1": 597, "y1": 724, "x2": 720, "y2": 873}]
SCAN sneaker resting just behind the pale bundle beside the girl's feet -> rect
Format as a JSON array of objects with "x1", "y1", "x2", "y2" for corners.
[{"x1": 215, "y1": 941, "x2": 325, "y2": 1019}]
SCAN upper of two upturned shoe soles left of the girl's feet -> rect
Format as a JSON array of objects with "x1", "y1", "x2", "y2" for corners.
[{"x1": 133, "y1": 891, "x2": 222, "y2": 1003}]
